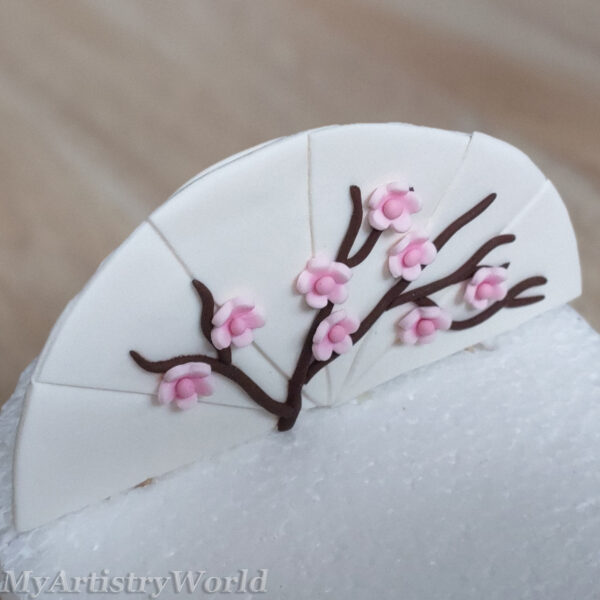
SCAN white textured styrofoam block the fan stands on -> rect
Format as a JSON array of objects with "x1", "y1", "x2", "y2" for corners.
[{"x1": 0, "y1": 308, "x2": 600, "y2": 600}]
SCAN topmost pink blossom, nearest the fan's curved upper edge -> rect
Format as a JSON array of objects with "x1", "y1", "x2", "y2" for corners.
[{"x1": 369, "y1": 181, "x2": 421, "y2": 233}]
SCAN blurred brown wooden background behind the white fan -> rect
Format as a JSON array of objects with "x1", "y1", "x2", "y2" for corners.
[{"x1": 0, "y1": 0, "x2": 600, "y2": 399}]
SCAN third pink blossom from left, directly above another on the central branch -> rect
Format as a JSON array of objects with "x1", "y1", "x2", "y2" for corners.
[{"x1": 296, "y1": 255, "x2": 352, "y2": 308}]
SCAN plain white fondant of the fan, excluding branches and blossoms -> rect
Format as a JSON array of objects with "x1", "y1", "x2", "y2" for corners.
[{"x1": 15, "y1": 124, "x2": 580, "y2": 529}]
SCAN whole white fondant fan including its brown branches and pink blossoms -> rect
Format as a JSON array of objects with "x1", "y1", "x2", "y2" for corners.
[{"x1": 14, "y1": 124, "x2": 580, "y2": 530}]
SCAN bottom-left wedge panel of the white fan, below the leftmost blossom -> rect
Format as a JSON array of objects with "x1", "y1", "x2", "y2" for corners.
[{"x1": 15, "y1": 381, "x2": 276, "y2": 528}]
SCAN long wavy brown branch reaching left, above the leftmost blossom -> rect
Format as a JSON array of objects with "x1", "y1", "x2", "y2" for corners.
[{"x1": 129, "y1": 350, "x2": 293, "y2": 417}]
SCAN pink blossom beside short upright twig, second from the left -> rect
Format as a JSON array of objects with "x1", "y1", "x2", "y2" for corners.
[{"x1": 210, "y1": 297, "x2": 265, "y2": 350}]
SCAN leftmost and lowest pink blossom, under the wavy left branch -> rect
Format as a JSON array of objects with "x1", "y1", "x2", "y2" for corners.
[{"x1": 158, "y1": 363, "x2": 213, "y2": 410}]
